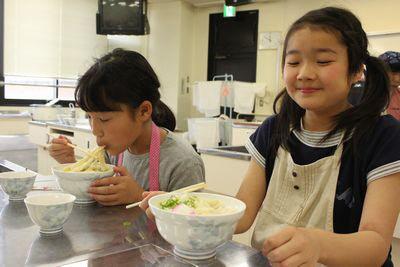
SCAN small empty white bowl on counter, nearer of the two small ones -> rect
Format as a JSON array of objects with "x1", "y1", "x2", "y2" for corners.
[{"x1": 24, "y1": 193, "x2": 76, "y2": 235}]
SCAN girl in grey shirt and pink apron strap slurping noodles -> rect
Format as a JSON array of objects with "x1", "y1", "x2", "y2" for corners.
[{"x1": 49, "y1": 49, "x2": 205, "y2": 205}]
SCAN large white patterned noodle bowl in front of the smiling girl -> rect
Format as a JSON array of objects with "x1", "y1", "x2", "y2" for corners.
[{"x1": 149, "y1": 193, "x2": 246, "y2": 260}]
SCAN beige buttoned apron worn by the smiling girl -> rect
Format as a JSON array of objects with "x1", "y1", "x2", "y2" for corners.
[{"x1": 252, "y1": 136, "x2": 343, "y2": 249}]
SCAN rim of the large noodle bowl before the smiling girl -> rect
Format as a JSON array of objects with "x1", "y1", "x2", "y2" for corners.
[{"x1": 149, "y1": 192, "x2": 246, "y2": 218}]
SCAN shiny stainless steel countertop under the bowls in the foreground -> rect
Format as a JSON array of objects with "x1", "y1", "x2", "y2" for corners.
[{"x1": 0, "y1": 177, "x2": 269, "y2": 266}]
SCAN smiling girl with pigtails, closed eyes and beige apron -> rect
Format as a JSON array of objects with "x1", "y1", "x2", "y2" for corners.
[{"x1": 141, "y1": 7, "x2": 400, "y2": 267}]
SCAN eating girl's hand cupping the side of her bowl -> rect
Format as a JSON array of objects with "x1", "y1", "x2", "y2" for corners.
[{"x1": 87, "y1": 166, "x2": 144, "y2": 206}]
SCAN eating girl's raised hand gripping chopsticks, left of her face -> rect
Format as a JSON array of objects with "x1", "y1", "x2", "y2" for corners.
[{"x1": 47, "y1": 135, "x2": 76, "y2": 164}]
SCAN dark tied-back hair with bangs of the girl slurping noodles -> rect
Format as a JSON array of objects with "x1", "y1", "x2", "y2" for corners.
[{"x1": 75, "y1": 48, "x2": 176, "y2": 131}]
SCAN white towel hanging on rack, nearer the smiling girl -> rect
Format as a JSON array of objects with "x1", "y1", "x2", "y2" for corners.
[{"x1": 233, "y1": 82, "x2": 266, "y2": 114}]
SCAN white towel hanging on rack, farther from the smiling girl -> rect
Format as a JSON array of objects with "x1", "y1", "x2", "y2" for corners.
[{"x1": 193, "y1": 81, "x2": 222, "y2": 117}]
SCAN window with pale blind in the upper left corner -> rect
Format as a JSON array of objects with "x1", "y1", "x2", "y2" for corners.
[{"x1": 0, "y1": 0, "x2": 108, "y2": 106}]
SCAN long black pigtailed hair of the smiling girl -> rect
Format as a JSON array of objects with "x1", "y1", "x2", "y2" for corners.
[{"x1": 267, "y1": 7, "x2": 390, "y2": 168}]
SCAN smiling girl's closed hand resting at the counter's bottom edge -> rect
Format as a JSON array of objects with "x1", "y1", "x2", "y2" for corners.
[{"x1": 262, "y1": 227, "x2": 321, "y2": 267}]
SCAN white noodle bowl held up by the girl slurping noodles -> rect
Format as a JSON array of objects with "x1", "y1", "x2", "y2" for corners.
[{"x1": 52, "y1": 163, "x2": 114, "y2": 205}]
